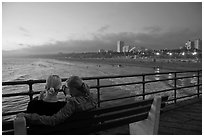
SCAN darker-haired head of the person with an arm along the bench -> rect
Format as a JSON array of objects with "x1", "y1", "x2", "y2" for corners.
[{"x1": 66, "y1": 76, "x2": 90, "y2": 97}]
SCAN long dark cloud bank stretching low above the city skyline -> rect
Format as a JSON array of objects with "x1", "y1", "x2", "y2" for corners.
[{"x1": 10, "y1": 26, "x2": 202, "y2": 54}]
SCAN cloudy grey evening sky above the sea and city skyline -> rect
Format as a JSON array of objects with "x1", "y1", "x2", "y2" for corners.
[{"x1": 2, "y1": 2, "x2": 202, "y2": 54}]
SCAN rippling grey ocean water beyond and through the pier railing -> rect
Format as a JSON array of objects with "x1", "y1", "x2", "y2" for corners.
[{"x1": 2, "y1": 58, "x2": 198, "y2": 120}]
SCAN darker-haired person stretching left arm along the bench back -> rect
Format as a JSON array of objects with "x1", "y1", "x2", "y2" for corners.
[{"x1": 17, "y1": 76, "x2": 96, "y2": 126}]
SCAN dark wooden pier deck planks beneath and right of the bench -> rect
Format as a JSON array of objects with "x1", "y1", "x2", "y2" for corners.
[{"x1": 96, "y1": 98, "x2": 202, "y2": 135}]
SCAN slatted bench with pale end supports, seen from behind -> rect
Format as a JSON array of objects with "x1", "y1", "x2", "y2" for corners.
[{"x1": 14, "y1": 96, "x2": 168, "y2": 135}]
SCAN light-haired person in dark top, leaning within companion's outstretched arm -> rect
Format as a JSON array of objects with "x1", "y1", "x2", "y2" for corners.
[{"x1": 27, "y1": 75, "x2": 66, "y2": 116}]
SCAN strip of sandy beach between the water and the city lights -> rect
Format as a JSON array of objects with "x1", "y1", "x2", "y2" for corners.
[{"x1": 54, "y1": 58, "x2": 202, "y2": 71}]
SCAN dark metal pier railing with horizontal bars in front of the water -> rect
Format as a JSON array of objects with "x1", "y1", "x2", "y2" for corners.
[{"x1": 2, "y1": 70, "x2": 202, "y2": 116}]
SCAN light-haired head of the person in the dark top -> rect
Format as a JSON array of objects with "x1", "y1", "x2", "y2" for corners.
[{"x1": 45, "y1": 75, "x2": 62, "y2": 95}]
